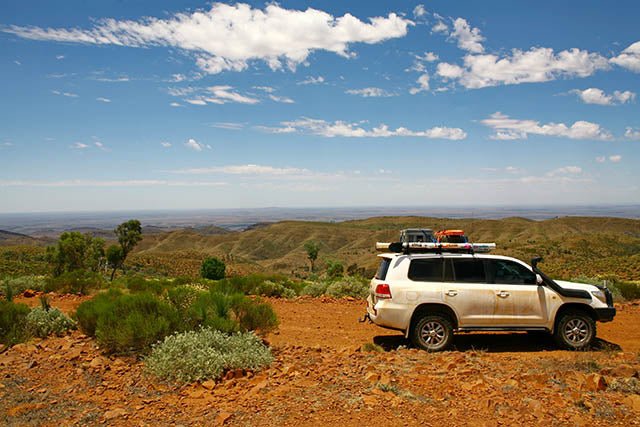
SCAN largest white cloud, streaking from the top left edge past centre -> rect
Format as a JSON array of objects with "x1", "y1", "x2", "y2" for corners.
[{"x1": 2, "y1": 3, "x2": 413, "y2": 73}]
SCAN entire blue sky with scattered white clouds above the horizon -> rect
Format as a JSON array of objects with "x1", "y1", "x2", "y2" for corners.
[{"x1": 0, "y1": 0, "x2": 640, "y2": 212}]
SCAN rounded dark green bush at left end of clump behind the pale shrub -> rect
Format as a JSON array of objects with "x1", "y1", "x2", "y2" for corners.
[{"x1": 95, "y1": 293, "x2": 179, "y2": 353}]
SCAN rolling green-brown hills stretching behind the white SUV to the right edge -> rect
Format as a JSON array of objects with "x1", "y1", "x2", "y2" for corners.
[{"x1": 132, "y1": 217, "x2": 640, "y2": 280}]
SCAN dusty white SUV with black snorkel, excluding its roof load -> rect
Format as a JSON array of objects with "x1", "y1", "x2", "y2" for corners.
[{"x1": 365, "y1": 253, "x2": 616, "y2": 351}]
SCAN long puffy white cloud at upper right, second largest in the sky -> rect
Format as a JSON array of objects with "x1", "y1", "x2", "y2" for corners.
[{"x1": 437, "y1": 47, "x2": 610, "y2": 89}]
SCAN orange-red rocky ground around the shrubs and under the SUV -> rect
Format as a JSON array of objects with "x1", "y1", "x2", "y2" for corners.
[{"x1": 0, "y1": 296, "x2": 640, "y2": 426}]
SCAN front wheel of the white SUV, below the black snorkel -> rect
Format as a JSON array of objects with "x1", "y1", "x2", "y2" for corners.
[{"x1": 553, "y1": 310, "x2": 596, "y2": 350}]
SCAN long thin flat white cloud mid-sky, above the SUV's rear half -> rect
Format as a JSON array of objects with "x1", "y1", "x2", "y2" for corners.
[{"x1": 259, "y1": 118, "x2": 467, "y2": 140}]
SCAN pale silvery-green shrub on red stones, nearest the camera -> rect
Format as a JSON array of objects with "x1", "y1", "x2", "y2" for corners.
[{"x1": 145, "y1": 328, "x2": 273, "y2": 383}]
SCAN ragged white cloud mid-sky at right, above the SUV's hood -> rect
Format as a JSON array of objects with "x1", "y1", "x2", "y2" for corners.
[{"x1": 481, "y1": 112, "x2": 612, "y2": 140}]
